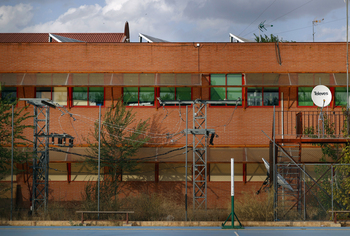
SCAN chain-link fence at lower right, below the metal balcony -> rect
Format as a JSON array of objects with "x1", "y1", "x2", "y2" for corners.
[{"x1": 276, "y1": 163, "x2": 350, "y2": 220}]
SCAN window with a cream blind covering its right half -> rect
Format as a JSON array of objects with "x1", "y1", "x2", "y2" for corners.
[{"x1": 36, "y1": 87, "x2": 67, "y2": 106}]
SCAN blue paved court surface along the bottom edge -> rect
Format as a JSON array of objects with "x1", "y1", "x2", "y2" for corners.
[{"x1": 0, "y1": 226, "x2": 350, "y2": 236}]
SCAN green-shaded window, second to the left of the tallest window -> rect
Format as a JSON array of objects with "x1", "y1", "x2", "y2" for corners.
[{"x1": 123, "y1": 87, "x2": 154, "y2": 106}]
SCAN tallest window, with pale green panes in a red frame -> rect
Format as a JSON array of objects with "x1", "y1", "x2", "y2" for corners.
[{"x1": 210, "y1": 74, "x2": 242, "y2": 105}]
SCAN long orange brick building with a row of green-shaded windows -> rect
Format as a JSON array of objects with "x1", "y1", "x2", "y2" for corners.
[{"x1": 0, "y1": 26, "x2": 346, "y2": 208}]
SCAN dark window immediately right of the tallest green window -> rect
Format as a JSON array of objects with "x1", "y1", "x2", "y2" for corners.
[{"x1": 247, "y1": 87, "x2": 279, "y2": 106}]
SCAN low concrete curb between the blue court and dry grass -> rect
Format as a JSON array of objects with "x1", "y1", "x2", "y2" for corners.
[{"x1": 0, "y1": 220, "x2": 341, "y2": 227}]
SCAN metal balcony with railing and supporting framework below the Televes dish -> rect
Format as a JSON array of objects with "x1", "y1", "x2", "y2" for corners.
[{"x1": 269, "y1": 108, "x2": 349, "y2": 221}]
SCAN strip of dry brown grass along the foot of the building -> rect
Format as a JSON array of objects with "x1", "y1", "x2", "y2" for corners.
[{"x1": 0, "y1": 188, "x2": 320, "y2": 221}]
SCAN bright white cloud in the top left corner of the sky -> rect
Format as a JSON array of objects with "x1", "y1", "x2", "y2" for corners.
[{"x1": 0, "y1": 3, "x2": 33, "y2": 33}]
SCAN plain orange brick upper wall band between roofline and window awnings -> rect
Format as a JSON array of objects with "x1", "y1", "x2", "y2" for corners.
[{"x1": 0, "y1": 43, "x2": 346, "y2": 73}]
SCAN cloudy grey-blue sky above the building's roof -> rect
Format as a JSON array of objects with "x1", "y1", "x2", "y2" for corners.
[{"x1": 0, "y1": 0, "x2": 346, "y2": 42}]
